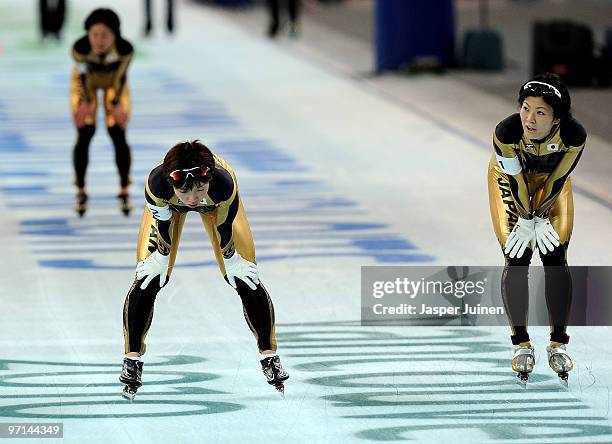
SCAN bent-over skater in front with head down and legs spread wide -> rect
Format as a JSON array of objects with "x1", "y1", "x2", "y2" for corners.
[{"x1": 119, "y1": 140, "x2": 289, "y2": 399}]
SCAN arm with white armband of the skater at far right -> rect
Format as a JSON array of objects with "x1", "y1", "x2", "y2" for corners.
[{"x1": 493, "y1": 115, "x2": 531, "y2": 219}]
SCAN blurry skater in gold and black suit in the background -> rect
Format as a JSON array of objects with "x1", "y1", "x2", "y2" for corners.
[{"x1": 70, "y1": 9, "x2": 134, "y2": 216}]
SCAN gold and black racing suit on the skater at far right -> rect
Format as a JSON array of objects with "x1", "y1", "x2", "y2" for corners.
[{"x1": 488, "y1": 113, "x2": 586, "y2": 344}]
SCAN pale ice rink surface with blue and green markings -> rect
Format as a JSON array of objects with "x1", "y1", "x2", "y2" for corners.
[{"x1": 0, "y1": 0, "x2": 612, "y2": 444}]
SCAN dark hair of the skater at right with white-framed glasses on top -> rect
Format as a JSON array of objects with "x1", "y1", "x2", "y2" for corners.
[{"x1": 518, "y1": 72, "x2": 572, "y2": 120}]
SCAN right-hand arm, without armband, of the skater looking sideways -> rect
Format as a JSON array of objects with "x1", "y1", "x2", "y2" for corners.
[{"x1": 534, "y1": 120, "x2": 586, "y2": 217}]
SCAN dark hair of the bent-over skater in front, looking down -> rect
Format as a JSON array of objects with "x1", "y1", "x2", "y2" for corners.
[{"x1": 163, "y1": 140, "x2": 215, "y2": 191}]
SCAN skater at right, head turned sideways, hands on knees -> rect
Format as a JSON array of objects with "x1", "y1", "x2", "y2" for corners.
[{"x1": 488, "y1": 74, "x2": 586, "y2": 385}]
